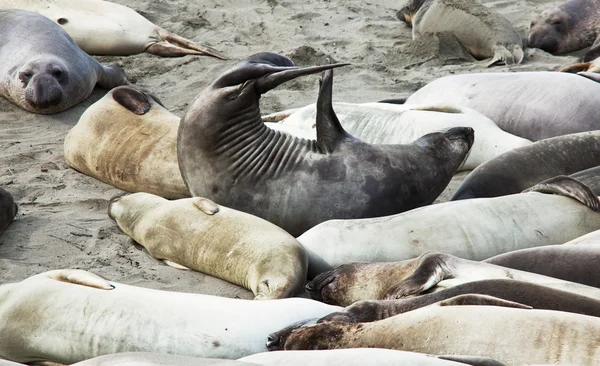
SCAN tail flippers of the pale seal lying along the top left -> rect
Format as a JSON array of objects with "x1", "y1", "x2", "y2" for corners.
[{"x1": 146, "y1": 28, "x2": 229, "y2": 60}]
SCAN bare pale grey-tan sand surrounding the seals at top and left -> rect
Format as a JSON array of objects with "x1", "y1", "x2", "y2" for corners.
[{"x1": 0, "y1": 0, "x2": 581, "y2": 298}]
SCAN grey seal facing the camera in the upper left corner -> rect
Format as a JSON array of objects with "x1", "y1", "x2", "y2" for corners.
[{"x1": 0, "y1": 10, "x2": 127, "y2": 114}]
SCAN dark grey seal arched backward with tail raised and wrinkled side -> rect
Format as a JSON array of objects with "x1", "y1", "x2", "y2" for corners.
[{"x1": 178, "y1": 53, "x2": 474, "y2": 236}]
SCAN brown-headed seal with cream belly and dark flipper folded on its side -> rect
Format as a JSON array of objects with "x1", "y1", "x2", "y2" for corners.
[{"x1": 306, "y1": 252, "x2": 600, "y2": 306}]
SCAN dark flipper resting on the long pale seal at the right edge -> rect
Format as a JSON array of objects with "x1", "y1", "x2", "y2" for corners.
[{"x1": 523, "y1": 175, "x2": 600, "y2": 212}]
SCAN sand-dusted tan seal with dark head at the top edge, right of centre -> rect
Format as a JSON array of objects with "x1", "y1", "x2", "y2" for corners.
[{"x1": 397, "y1": 0, "x2": 524, "y2": 66}]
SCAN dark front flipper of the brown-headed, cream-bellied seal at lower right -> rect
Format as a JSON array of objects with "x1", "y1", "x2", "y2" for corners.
[{"x1": 385, "y1": 252, "x2": 453, "y2": 300}]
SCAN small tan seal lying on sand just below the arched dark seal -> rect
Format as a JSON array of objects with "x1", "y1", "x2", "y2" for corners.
[{"x1": 108, "y1": 193, "x2": 308, "y2": 299}]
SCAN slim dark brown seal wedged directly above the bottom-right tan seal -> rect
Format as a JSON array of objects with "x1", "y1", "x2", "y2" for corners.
[{"x1": 318, "y1": 280, "x2": 600, "y2": 323}]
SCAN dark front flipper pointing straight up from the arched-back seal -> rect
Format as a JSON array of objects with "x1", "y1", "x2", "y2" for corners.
[{"x1": 317, "y1": 70, "x2": 353, "y2": 153}]
